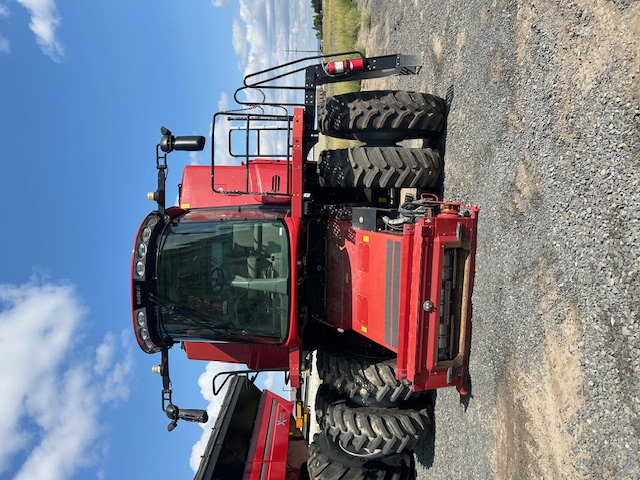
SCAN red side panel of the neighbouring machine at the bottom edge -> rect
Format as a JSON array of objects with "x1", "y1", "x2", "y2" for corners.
[{"x1": 244, "y1": 390, "x2": 293, "y2": 480}]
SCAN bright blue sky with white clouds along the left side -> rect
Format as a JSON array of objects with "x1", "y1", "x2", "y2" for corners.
[{"x1": 0, "y1": 0, "x2": 316, "y2": 480}]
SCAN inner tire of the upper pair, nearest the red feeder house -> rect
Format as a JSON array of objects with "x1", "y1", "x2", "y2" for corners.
[{"x1": 318, "y1": 147, "x2": 442, "y2": 188}]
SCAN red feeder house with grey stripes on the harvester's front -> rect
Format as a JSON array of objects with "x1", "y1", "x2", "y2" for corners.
[{"x1": 326, "y1": 204, "x2": 477, "y2": 390}]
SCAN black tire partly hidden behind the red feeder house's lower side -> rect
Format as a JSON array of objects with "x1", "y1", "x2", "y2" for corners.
[{"x1": 316, "y1": 350, "x2": 418, "y2": 406}]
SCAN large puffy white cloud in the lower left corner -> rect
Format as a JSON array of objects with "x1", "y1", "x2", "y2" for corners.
[{"x1": 0, "y1": 280, "x2": 131, "y2": 480}]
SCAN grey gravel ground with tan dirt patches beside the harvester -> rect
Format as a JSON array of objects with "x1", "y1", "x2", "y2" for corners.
[{"x1": 358, "y1": 0, "x2": 640, "y2": 479}]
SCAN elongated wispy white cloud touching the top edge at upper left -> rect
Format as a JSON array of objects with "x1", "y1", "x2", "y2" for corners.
[{"x1": 18, "y1": 0, "x2": 64, "y2": 63}]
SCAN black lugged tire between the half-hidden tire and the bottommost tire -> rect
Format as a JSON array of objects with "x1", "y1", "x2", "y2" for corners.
[{"x1": 316, "y1": 386, "x2": 432, "y2": 459}]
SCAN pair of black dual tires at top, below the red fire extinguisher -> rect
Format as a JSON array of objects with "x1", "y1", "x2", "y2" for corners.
[{"x1": 318, "y1": 90, "x2": 446, "y2": 189}]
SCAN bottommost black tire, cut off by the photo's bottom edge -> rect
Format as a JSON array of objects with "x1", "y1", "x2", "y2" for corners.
[{"x1": 307, "y1": 432, "x2": 414, "y2": 480}]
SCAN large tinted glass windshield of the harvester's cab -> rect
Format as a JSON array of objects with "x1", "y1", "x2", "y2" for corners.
[{"x1": 157, "y1": 219, "x2": 290, "y2": 343}]
